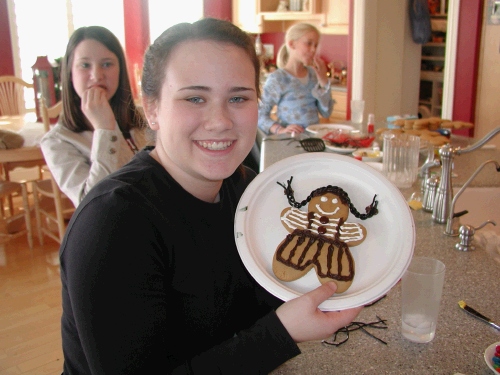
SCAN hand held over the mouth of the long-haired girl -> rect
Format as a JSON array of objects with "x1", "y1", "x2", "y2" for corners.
[{"x1": 82, "y1": 86, "x2": 116, "y2": 130}]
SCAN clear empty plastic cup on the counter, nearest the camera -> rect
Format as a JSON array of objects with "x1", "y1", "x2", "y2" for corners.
[{"x1": 401, "y1": 257, "x2": 445, "y2": 343}]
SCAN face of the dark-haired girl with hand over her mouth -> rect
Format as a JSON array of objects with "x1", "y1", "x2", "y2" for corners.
[{"x1": 71, "y1": 39, "x2": 120, "y2": 100}]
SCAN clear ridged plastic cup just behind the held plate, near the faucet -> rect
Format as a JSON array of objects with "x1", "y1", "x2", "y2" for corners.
[{"x1": 382, "y1": 132, "x2": 420, "y2": 188}]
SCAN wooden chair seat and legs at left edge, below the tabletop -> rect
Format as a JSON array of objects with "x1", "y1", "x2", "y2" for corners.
[{"x1": 0, "y1": 180, "x2": 33, "y2": 249}]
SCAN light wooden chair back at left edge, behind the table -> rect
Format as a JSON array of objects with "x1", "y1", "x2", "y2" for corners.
[{"x1": 0, "y1": 76, "x2": 33, "y2": 116}]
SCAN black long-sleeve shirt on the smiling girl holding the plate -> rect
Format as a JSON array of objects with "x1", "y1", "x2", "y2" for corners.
[{"x1": 60, "y1": 151, "x2": 300, "y2": 374}]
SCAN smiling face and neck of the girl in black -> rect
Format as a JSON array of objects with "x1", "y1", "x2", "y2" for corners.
[{"x1": 144, "y1": 40, "x2": 258, "y2": 200}]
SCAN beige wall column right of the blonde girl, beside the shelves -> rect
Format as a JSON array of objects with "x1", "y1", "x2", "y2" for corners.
[{"x1": 352, "y1": 0, "x2": 421, "y2": 122}]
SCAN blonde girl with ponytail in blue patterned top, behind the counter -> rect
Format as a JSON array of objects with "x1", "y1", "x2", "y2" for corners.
[{"x1": 259, "y1": 23, "x2": 334, "y2": 134}]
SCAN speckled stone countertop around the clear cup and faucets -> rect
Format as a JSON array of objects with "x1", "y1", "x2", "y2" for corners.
[{"x1": 264, "y1": 137, "x2": 500, "y2": 375}]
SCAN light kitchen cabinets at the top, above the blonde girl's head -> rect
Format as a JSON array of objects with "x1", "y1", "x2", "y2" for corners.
[{"x1": 232, "y1": 0, "x2": 350, "y2": 34}]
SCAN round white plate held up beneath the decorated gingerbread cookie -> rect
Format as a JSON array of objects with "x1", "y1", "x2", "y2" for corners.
[{"x1": 234, "y1": 153, "x2": 415, "y2": 310}]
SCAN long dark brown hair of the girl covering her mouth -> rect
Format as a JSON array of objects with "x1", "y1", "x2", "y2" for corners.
[{"x1": 60, "y1": 26, "x2": 145, "y2": 133}]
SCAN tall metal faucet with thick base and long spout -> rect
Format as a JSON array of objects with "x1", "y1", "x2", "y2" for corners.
[{"x1": 432, "y1": 127, "x2": 500, "y2": 224}]
